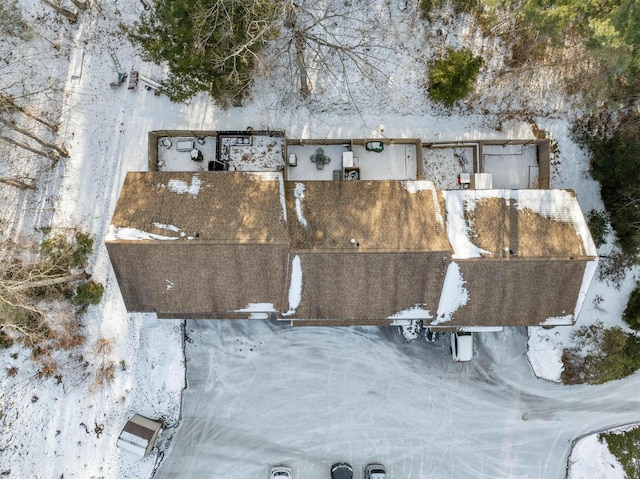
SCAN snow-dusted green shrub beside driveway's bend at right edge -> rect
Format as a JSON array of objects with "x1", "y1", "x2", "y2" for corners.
[{"x1": 562, "y1": 322, "x2": 640, "y2": 384}]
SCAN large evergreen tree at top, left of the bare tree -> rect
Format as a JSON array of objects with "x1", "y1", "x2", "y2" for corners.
[{"x1": 124, "y1": 0, "x2": 283, "y2": 105}]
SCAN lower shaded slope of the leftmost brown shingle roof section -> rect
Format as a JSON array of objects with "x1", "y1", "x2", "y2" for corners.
[{"x1": 107, "y1": 241, "x2": 288, "y2": 319}]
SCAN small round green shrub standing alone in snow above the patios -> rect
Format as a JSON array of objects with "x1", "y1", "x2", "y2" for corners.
[{"x1": 429, "y1": 49, "x2": 484, "y2": 107}]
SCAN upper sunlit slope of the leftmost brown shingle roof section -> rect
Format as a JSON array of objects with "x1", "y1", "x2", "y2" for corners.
[{"x1": 111, "y1": 172, "x2": 288, "y2": 243}]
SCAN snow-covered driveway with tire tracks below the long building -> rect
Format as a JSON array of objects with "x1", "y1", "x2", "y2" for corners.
[{"x1": 155, "y1": 321, "x2": 640, "y2": 479}]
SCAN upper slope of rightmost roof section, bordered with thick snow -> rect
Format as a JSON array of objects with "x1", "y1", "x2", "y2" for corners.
[{"x1": 443, "y1": 190, "x2": 597, "y2": 259}]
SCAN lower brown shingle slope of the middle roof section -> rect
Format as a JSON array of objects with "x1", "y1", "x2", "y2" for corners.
[{"x1": 291, "y1": 252, "x2": 449, "y2": 324}]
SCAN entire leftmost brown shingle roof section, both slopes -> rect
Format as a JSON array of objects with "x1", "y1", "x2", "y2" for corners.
[{"x1": 107, "y1": 172, "x2": 289, "y2": 318}]
